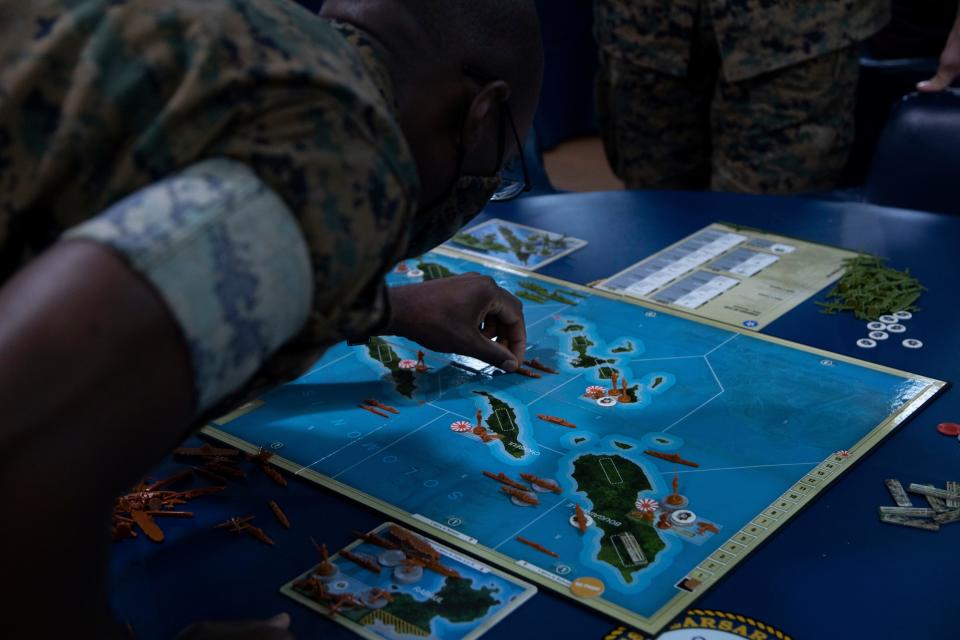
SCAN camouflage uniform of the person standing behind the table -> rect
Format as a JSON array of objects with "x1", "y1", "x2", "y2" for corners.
[{"x1": 595, "y1": 0, "x2": 889, "y2": 193}]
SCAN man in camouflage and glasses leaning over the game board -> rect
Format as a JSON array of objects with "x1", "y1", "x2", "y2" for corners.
[{"x1": 0, "y1": 0, "x2": 543, "y2": 638}]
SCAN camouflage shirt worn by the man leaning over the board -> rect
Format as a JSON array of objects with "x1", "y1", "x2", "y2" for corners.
[{"x1": 0, "y1": 0, "x2": 418, "y2": 407}]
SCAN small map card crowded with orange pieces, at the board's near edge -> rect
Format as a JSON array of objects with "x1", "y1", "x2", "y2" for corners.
[{"x1": 280, "y1": 522, "x2": 537, "y2": 640}]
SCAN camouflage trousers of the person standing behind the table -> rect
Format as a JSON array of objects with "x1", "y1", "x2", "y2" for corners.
[{"x1": 597, "y1": 20, "x2": 859, "y2": 194}]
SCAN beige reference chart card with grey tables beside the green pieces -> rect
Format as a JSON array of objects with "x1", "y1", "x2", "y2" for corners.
[{"x1": 596, "y1": 223, "x2": 857, "y2": 330}]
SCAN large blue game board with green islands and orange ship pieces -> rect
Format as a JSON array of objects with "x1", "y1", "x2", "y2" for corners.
[{"x1": 208, "y1": 250, "x2": 945, "y2": 633}]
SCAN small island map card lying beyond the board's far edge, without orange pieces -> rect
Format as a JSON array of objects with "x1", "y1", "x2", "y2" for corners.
[{"x1": 444, "y1": 218, "x2": 587, "y2": 271}]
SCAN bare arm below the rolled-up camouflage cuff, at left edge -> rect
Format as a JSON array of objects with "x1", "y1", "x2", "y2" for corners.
[{"x1": 0, "y1": 242, "x2": 193, "y2": 637}]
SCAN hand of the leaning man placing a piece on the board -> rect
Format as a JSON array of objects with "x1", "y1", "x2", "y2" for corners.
[{"x1": 388, "y1": 273, "x2": 527, "y2": 371}]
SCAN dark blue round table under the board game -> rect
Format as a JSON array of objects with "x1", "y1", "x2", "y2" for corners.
[{"x1": 114, "y1": 192, "x2": 960, "y2": 640}]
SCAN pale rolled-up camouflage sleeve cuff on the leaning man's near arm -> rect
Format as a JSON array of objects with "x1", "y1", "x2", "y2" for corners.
[{"x1": 64, "y1": 159, "x2": 313, "y2": 414}]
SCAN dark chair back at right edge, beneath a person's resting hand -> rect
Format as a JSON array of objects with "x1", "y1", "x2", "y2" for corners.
[{"x1": 864, "y1": 89, "x2": 960, "y2": 214}]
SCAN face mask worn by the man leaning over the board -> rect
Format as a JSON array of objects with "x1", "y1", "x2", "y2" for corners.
[{"x1": 406, "y1": 175, "x2": 500, "y2": 259}]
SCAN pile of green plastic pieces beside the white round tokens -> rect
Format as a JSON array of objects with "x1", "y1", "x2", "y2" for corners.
[{"x1": 816, "y1": 255, "x2": 927, "y2": 320}]
